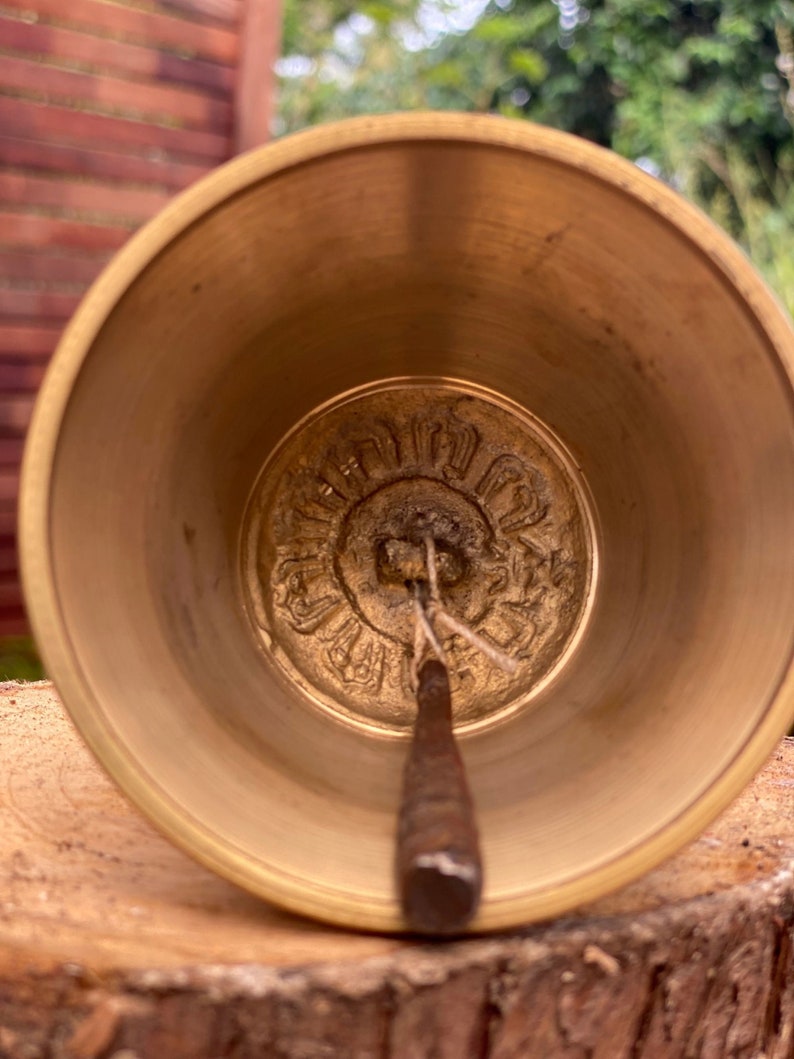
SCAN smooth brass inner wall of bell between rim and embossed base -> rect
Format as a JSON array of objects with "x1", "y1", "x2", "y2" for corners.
[{"x1": 46, "y1": 141, "x2": 794, "y2": 925}]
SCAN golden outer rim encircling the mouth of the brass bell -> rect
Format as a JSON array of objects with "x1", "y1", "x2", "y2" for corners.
[{"x1": 19, "y1": 113, "x2": 794, "y2": 933}]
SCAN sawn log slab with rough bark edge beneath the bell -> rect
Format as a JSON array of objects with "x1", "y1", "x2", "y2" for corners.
[{"x1": 0, "y1": 683, "x2": 794, "y2": 1059}]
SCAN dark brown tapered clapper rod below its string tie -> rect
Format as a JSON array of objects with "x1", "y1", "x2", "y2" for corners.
[{"x1": 397, "y1": 660, "x2": 483, "y2": 935}]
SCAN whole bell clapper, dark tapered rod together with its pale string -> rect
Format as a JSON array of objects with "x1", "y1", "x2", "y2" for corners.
[{"x1": 397, "y1": 536, "x2": 517, "y2": 935}]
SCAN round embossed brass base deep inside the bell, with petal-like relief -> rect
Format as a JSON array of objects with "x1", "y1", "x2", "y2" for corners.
[{"x1": 242, "y1": 380, "x2": 594, "y2": 731}]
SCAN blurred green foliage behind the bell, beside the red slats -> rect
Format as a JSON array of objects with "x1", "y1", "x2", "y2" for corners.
[{"x1": 279, "y1": 0, "x2": 794, "y2": 309}]
